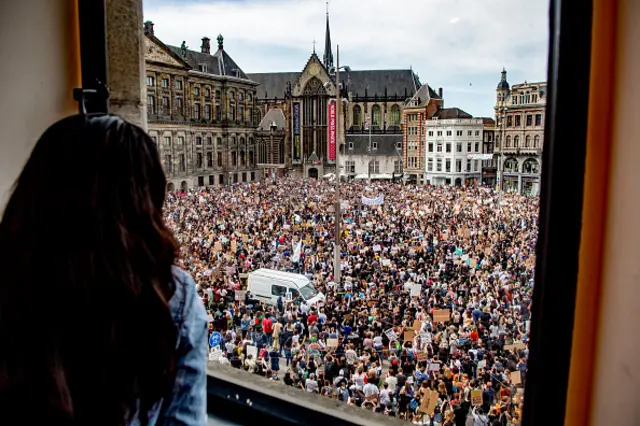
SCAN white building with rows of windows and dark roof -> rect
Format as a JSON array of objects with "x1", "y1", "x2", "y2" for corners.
[{"x1": 424, "y1": 108, "x2": 484, "y2": 186}]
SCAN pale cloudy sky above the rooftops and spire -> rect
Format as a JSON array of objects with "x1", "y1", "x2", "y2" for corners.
[{"x1": 143, "y1": 0, "x2": 549, "y2": 117}]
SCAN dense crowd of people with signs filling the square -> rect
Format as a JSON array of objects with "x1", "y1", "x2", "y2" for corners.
[{"x1": 165, "y1": 179, "x2": 538, "y2": 425}]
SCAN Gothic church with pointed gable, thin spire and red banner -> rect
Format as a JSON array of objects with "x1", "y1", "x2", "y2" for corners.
[{"x1": 247, "y1": 10, "x2": 438, "y2": 177}]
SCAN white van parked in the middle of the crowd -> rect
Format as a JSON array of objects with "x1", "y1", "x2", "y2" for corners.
[{"x1": 247, "y1": 268, "x2": 324, "y2": 306}]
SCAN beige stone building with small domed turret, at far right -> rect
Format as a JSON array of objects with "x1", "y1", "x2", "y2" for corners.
[{"x1": 494, "y1": 69, "x2": 547, "y2": 195}]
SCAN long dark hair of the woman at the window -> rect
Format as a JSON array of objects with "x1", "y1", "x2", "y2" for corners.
[{"x1": 0, "y1": 114, "x2": 177, "y2": 426}]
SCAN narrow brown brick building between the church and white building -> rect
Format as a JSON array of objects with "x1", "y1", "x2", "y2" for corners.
[{"x1": 402, "y1": 84, "x2": 444, "y2": 184}]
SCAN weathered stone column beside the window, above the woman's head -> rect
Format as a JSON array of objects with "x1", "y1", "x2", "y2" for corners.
[{"x1": 107, "y1": 0, "x2": 147, "y2": 130}]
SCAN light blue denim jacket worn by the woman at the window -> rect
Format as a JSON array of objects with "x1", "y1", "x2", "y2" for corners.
[{"x1": 130, "y1": 268, "x2": 208, "y2": 426}]
